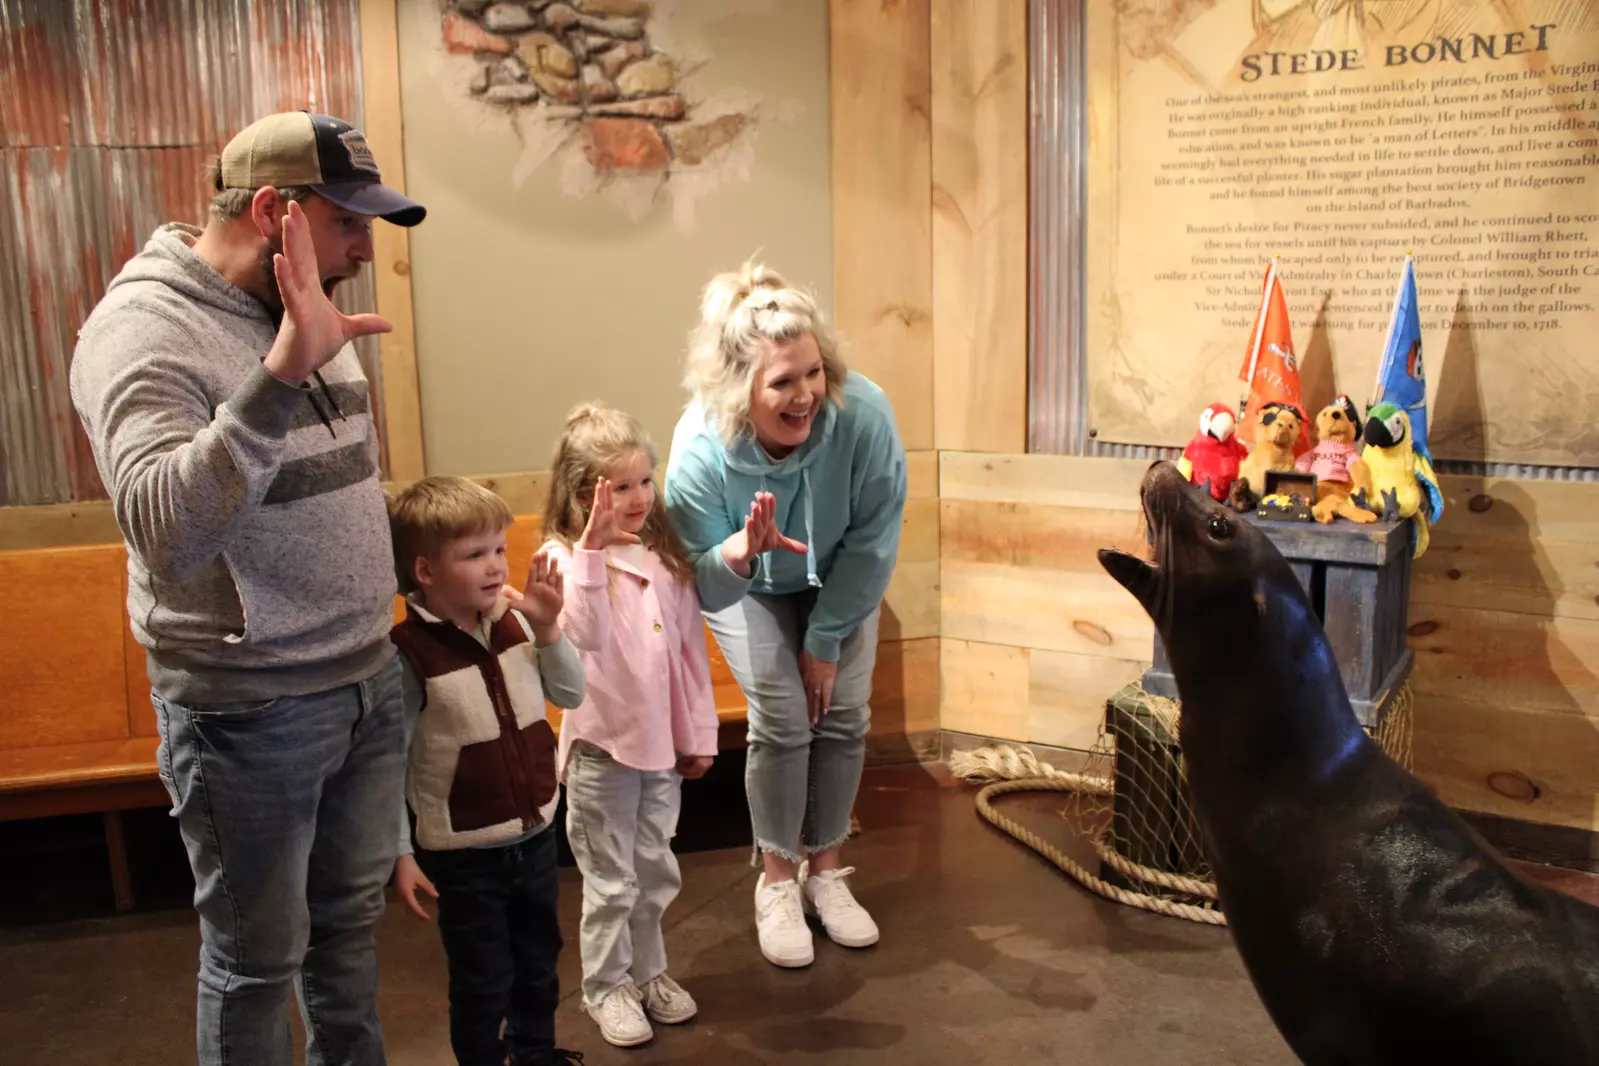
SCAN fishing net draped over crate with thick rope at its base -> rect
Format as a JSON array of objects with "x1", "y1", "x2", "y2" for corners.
[{"x1": 950, "y1": 684, "x2": 1412, "y2": 925}]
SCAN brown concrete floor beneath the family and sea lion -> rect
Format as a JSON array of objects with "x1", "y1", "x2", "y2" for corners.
[{"x1": 9, "y1": 767, "x2": 1599, "y2": 1066}]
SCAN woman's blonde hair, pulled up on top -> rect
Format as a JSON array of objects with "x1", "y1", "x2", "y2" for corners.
[{"x1": 683, "y1": 261, "x2": 849, "y2": 447}]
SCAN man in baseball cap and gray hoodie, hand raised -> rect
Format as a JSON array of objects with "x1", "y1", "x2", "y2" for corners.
[{"x1": 70, "y1": 112, "x2": 425, "y2": 1066}]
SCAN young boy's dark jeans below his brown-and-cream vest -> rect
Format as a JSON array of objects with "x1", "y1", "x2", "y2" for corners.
[{"x1": 416, "y1": 829, "x2": 561, "y2": 1066}]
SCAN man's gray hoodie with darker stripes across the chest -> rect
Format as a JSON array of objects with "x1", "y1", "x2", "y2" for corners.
[{"x1": 72, "y1": 224, "x2": 395, "y2": 703}]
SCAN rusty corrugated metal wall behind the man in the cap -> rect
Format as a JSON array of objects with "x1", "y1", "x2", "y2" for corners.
[{"x1": 0, "y1": 0, "x2": 382, "y2": 505}]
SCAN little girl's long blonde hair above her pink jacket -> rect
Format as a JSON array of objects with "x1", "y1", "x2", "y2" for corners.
[{"x1": 544, "y1": 403, "x2": 694, "y2": 582}]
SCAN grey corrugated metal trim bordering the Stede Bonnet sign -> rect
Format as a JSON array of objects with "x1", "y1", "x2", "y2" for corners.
[{"x1": 1027, "y1": 0, "x2": 1599, "y2": 481}]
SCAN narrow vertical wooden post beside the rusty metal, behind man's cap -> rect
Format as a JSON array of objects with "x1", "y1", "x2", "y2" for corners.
[{"x1": 361, "y1": 0, "x2": 427, "y2": 481}]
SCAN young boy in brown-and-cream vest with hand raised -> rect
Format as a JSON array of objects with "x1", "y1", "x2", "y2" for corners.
[{"x1": 389, "y1": 478, "x2": 585, "y2": 1066}]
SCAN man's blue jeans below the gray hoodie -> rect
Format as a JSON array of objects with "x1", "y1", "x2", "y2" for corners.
[{"x1": 152, "y1": 658, "x2": 405, "y2": 1066}]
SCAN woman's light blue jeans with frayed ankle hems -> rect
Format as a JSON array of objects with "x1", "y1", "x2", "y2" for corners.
[{"x1": 705, "y1": 590, "x2": 883, "y2": 861}]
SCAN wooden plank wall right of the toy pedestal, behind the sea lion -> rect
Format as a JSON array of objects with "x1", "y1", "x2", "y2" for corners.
[{"x1": 1409, "y1": 476, "x2": 1599, "y2": 831}]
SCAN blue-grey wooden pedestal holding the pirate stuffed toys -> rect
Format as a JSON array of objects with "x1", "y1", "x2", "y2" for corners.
[{"x1": 1143, "y1": 515, "x2": 1414, "y2": 729}]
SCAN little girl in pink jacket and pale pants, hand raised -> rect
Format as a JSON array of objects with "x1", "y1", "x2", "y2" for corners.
[{"x1": 544, "y1": 404, "x2": 716, "y2": 1047}]
